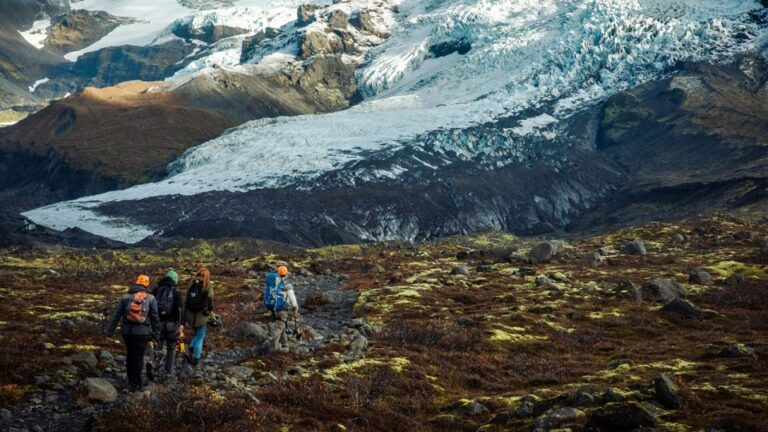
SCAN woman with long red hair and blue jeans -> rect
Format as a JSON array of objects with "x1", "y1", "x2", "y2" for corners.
[{"x1": 184, "y1": 267, "x2": 213, "y2": 366}]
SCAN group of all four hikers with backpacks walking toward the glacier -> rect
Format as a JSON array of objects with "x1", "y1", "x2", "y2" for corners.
[{"x1": 106, "y1": 265, "x2": 299, "y2": 391}]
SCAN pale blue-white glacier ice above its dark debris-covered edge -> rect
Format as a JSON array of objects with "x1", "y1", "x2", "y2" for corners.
[{"x1": 25, "y1": 0, "x2": 765, "y2": 242}]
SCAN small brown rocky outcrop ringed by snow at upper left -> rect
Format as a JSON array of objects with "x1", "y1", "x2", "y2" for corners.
[{"x1": 43, "y1": 10, "x2": 134, "y2": 55}]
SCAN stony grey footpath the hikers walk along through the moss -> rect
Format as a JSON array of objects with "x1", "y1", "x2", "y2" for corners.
[{"x1": 0, "y1": 271, "x2": 374, "y2": 432}]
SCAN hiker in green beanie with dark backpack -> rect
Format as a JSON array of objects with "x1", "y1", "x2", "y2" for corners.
[{"x1": 152, "y1": 270, "x2": 183, "y2": 376}]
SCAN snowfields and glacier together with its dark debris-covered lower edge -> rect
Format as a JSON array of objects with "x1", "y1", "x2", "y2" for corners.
[{"x1": 9, "y1": 0, "x2": 766, "y2": 243}]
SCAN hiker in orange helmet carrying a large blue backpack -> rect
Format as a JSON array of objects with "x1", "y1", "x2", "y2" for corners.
[{"x1": 264, "y1": 265, "x2": 299, "y2": 352}]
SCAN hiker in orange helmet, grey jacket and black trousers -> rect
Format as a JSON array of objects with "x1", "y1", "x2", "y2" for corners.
[{"x1": 106, "y1": 275, "x2": 160, "y2": 391}]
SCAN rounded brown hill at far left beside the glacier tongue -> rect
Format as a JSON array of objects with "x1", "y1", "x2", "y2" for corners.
[{"x1": 0, "y1": 83, "x2": 233, "y2": 209}]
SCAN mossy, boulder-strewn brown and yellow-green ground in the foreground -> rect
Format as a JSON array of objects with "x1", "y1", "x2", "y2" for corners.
[{"x1": 0, "y1": 217, "x2": 768, "y2": 432}]
